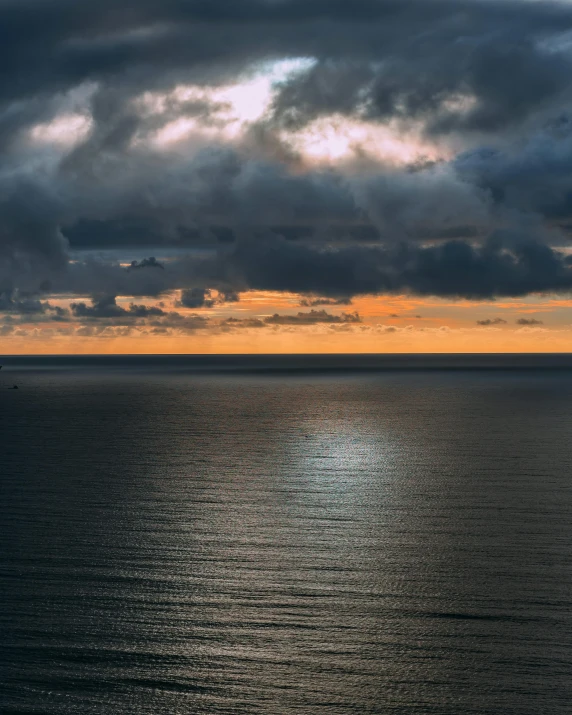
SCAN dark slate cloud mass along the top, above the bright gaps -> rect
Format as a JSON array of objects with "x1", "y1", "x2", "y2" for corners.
[{"x1": 0, "y1": 0, "x2": 572, "y2": 136}]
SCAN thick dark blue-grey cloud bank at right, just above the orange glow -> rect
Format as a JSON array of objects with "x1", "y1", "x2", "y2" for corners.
[{"x1": 219, "y1": 234, "x2": 572, "y2": 299}]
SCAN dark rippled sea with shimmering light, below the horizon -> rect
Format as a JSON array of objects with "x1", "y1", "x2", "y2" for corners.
[{"x1": 0, "y1": 358, "x2": 572, "y2": 715}]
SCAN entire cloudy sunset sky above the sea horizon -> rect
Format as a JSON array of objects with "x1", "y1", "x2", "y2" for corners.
[{"x1": 5, "y1": 0, "x2": 572, "y2": 354}]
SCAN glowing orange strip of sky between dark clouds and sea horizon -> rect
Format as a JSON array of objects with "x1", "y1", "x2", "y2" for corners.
[{"x1": 4, "y1": 291, "x2": 572, "y2": 354}]
